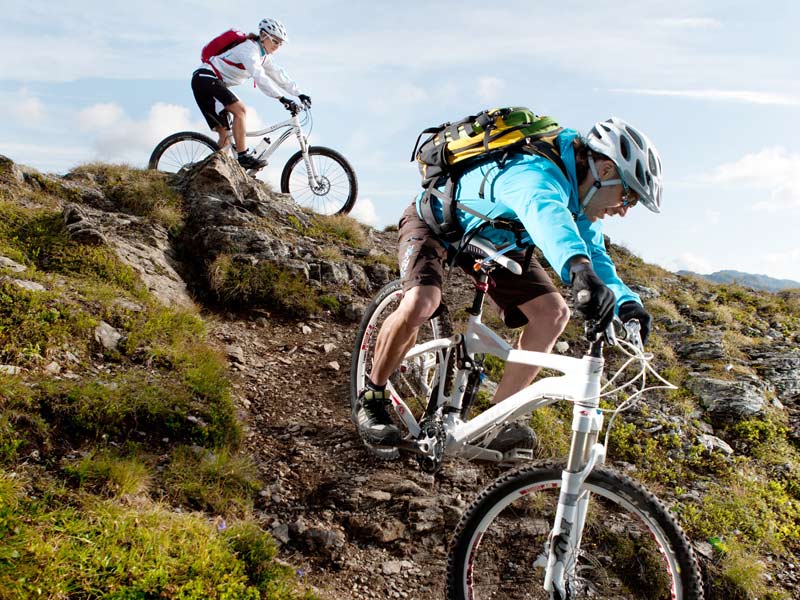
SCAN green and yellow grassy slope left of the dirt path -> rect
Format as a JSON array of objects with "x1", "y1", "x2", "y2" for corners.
[{"x1": 0, "y1": 166, "x2": 312, "y2": 600}]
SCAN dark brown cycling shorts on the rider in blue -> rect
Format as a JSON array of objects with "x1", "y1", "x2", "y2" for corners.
[{"x1": 397, "y1": 203, "x2": 558, "y2": 327}]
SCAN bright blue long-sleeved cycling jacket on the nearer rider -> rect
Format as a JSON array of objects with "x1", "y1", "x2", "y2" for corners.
[{"x1": 417, "y1": 129, "x2": 641, "y2": 308}]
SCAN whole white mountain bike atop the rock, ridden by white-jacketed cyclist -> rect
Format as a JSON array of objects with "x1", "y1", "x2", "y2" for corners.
[{"x1": 149, "y1": 109, "x2": 358, "y2": 215}]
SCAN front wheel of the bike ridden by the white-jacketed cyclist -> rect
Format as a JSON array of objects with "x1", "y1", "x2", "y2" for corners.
[{"x1": 281, "y1": 146, "x2": 358, "y2": 215}]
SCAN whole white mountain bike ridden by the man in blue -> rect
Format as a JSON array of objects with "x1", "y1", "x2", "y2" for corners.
[{"x1": 351, "y1": 237, "x2": 703, "y2": 600}]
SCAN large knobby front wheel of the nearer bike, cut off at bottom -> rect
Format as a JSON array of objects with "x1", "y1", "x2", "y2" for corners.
[{"x1": 447, "y1": 466, "x2": 703, "y2": 600}]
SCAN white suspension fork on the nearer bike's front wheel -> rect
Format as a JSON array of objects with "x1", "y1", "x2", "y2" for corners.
[{"x1": 544, "y1": 404, "x2": 606, "y2": 597}]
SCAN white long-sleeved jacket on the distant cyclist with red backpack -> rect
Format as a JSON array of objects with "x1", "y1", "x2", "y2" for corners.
[{"x1": 202, "y1": 40, "x2": 300, "y2": 98}]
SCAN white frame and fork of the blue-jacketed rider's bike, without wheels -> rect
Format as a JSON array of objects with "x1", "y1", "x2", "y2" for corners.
[{"x1": 384, "y1": 266, "x2": 620, "y2": 596}]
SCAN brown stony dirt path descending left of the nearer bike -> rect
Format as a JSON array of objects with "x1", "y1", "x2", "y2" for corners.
[{"x1": 212, "y1": 318, "x2": 492, "y2": 599}]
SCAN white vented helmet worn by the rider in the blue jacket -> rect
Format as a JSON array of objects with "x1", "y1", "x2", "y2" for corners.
[{"x1": 586, "y1": 117, "x2": 663, "y2": 213}]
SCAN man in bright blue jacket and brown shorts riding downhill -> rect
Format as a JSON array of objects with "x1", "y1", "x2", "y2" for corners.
[{"x1": 358, "y1": 117, "x2": 662, "y2": 452}]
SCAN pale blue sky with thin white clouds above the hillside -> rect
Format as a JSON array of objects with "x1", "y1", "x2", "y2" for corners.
[{"x1": 0, "y1": 0, "x2": 800, "y2": 285}]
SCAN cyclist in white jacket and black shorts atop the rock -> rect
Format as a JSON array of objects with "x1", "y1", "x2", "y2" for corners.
[{"x1": 192, "y1": 19, "x2": 311, "y2": 169}]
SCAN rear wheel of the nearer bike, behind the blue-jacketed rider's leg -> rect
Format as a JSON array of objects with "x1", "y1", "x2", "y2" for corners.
[{"x1": 350, "y1": 279, "x2": 454, "y2": 460}]
